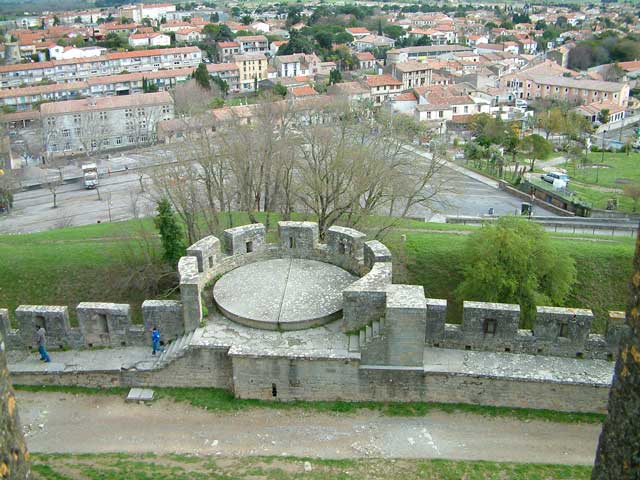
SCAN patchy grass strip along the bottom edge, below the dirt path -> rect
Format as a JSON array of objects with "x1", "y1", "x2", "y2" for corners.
[{"x1": 31, "y1": 453, "x2": 591, "y2": 480}]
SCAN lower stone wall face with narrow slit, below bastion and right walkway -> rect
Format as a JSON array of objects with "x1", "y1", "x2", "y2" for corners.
[{"x1": 233, "y1": 357, "x2": 609, "y2": 413}]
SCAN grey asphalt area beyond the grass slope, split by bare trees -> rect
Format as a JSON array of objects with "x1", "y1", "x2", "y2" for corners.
[{"x1": 0, "y1": 145, "x2": 551, "y2": 233}]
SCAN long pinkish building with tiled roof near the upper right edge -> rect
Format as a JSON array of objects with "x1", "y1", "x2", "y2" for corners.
[{"x1": 499, "y1": 70, "x2": 629, "y2": 107}]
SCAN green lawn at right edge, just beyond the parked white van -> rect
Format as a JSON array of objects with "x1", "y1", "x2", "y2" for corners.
[{"x1": 567, "y1": 152, "x2": 640, "y2": 188}]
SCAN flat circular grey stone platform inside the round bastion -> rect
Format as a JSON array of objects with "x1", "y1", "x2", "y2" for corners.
[{"x1": 213, "y1": 258, "x2": 358, "y2": 330}]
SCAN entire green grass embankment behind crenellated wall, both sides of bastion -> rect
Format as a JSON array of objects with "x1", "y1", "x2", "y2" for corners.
[{"x1": 0, "y1": 214, "x2": 633, "y2": 331}]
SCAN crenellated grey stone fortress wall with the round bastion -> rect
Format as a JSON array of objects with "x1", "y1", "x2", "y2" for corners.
[{"x1": 0, "y1": 222, "x2": 626, "y2": 411}]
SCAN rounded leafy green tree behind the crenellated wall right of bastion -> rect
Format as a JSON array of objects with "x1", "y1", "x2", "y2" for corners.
[{"x1": 456, "y1": 218, "x2": 576, "y2": 327}]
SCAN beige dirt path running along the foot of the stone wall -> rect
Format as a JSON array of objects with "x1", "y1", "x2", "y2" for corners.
[{"x1": 18, "y1": 391, "x2": 600, "y2": 464}]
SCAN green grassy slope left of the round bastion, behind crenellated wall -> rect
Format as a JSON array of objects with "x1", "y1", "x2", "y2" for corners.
[{"x1": 0, "y1": 223, "x2": 156, "y2": 326}]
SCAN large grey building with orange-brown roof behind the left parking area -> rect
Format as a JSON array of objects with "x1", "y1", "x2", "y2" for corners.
[{"x1": 40, "y1": 92, "x2": 174, "y2": 155}]
